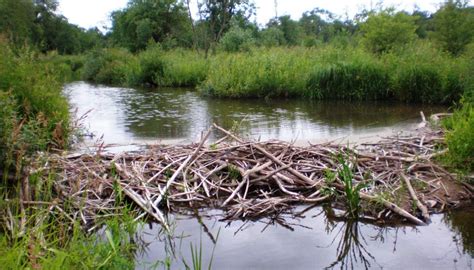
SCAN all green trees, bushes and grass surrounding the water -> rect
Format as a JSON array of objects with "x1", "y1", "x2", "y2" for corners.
[{"x1": 0, "y1": 0, "x2": 474, "y2": 269}]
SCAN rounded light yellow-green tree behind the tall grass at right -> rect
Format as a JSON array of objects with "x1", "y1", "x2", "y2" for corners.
[{"x1": 360, "y1": 9, "x2": 416, "y2": 53}]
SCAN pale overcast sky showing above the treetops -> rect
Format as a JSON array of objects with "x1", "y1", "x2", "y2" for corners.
[{"x1": 59, "y1": 0, "x2": 462, "y2": 28}]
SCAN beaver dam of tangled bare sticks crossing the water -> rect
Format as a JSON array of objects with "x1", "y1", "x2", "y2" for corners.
[{"x1": 22, "y1": 122, "x2": 473, "y2": 232}]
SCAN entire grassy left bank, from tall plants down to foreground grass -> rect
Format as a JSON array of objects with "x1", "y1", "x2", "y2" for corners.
[{"x1": 0, "y1": 41, "x2": 140, "y2": 269}]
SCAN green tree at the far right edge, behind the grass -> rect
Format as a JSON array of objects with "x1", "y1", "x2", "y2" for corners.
[{"x1": 433, "y1": 0, "x2": 474, "y2": 55}]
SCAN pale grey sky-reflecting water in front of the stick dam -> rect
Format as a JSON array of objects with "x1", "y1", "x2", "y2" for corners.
[{"x1": 133, "y1": 207, "x2": 474, "y2": 269}]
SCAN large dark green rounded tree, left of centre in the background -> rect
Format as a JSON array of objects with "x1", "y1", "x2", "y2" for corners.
[{"x1": 111, "y1": 0, "x2": 192, "y2": 52}]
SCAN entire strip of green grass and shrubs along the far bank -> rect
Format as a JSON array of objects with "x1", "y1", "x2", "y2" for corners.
[{"x1": 82, "y1": 41, "x2": 469, "y2": 105}]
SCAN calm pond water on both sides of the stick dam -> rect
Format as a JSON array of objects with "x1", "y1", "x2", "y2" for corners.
[{"x1": 65, "y1": 82, "x2": 474, "y2": 269}]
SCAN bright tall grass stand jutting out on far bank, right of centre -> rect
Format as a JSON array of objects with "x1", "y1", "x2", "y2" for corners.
[{"x1": 200, "y1": 43, "x2": 469, "y2": 104}]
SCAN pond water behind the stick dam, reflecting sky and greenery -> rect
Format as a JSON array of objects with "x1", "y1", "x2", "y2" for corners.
[{"x1": 65, "y1": 82, "x2": 445, "y2": 144}]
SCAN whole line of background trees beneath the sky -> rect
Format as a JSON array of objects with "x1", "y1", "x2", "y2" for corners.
[{"x1": 0, "y1": 0, "x2": 474, "y2": 55}]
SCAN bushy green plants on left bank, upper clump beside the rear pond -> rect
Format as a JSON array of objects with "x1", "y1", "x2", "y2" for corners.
[{"x1": 0, "y1": 42, "x2": 69, "y2": 175}]
